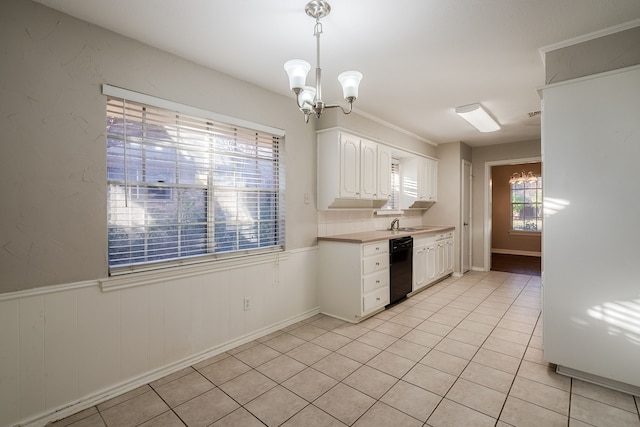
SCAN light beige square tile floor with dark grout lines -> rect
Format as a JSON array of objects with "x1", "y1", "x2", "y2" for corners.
[{"x1": 54, "y1": 272, "x2": 640, "y2": 427}]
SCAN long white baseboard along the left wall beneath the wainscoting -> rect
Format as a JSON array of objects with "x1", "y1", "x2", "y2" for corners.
[{"x1": 25, "y1": 307, "x2": 320, "y2": 427}]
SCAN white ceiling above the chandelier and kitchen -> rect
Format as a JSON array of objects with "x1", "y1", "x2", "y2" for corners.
[{"x1": 37, "y1": 0, "x2": 640, "y2": 146}]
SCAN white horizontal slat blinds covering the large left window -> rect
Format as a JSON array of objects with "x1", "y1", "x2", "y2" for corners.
[{"x1": 107, "y1": 96, "x2": 284, "y2": 274}]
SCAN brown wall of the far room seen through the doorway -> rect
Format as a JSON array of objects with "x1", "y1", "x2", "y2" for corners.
[{"x1": 491, "y1": 162, "x2": 542, "y2": 254}]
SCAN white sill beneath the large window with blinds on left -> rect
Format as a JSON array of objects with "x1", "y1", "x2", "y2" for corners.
[{"x1": 98, "y1": 251, "x2": 289, "y2": 292}]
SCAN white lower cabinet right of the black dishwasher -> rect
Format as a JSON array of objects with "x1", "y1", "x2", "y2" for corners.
[{"x1": 412, "y1": 231, "x2": 454, "y2": 292}]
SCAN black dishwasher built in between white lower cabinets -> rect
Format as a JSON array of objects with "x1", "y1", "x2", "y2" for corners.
[{"x1": 389, "y1": 236, "x2": 413, "y2": 305}]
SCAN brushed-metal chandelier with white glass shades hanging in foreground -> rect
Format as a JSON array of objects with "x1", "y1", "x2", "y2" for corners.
[{"x1": 284, "y1": 0, "x2": 362, "y2": 123}]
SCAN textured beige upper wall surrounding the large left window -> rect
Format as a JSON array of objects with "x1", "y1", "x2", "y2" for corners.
[{"x1": 0, "y1": 0, "x2": 317, "y2": 292}]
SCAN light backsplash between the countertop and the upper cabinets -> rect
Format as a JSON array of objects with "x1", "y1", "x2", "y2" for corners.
[{"x1": 318, "y1": 209, "x2": 423, "y2": 237}]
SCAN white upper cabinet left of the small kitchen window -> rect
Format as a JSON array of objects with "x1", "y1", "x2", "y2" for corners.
[{"x1": 318, "y1": 130, "x2": 391, "y2": 210}]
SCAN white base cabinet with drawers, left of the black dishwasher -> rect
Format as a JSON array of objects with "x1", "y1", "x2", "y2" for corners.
[{"x1": 318, "y1": 240, "x2": 389, "y2": 323}]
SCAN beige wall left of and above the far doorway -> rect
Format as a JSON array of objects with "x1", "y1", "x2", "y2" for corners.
[{"x1": 471, "y1": 140, "x2": 541, "y2": 270}]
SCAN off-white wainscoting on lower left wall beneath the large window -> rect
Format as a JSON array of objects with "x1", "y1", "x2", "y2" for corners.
[{"x1": 0, "y1": 247, "x2": 318, "y2": 426}]
